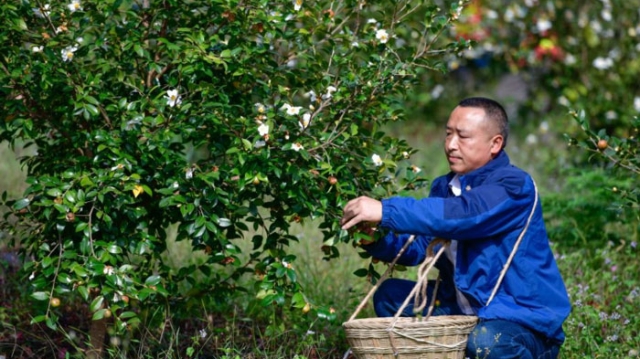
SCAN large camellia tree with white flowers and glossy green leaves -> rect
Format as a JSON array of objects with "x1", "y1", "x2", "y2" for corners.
[{"x1": 0, "y1": 0, "x2": 469, "y2": 356}]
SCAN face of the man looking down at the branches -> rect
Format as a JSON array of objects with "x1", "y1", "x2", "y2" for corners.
[{"x1": 444, "y1": 106, "x2": 503, "y2": 174}]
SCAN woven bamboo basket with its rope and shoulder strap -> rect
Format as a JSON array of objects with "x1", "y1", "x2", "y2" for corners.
[{"x1": 342, "y1": 182, "x2": 538, "y2": 359}]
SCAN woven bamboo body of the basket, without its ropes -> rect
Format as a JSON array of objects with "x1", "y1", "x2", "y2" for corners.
[{"x1": 343, "y1": 315, "x2": 478, "y2": 359}]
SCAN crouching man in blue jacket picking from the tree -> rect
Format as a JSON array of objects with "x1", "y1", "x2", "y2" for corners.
[{"x1": 341, "y1": 97, "x2": 571, "y2": 359}]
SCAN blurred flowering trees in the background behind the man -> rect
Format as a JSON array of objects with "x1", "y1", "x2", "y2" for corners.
[{"x1": 400, "y1": 0, "x2": 640, "y2": 250}]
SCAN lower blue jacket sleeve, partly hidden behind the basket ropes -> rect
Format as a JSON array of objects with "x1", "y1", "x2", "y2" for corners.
[{"x1": 362, "y1": 232, "x2": 431, "y2": 266}]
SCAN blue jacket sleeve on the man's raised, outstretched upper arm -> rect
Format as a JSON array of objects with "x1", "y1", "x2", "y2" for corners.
[{"x1": 380, "y1": 176, "x2": 535, "y2": 240}]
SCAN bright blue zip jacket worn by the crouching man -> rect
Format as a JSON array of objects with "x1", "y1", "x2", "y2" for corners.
[{"x1": 364, "y1": 151, "x2": 571, "y2": 343}]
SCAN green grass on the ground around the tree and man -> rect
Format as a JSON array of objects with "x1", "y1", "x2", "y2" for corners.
[{"x1": 0, "y1": 121, "x2": 640, "y2": 359}]
